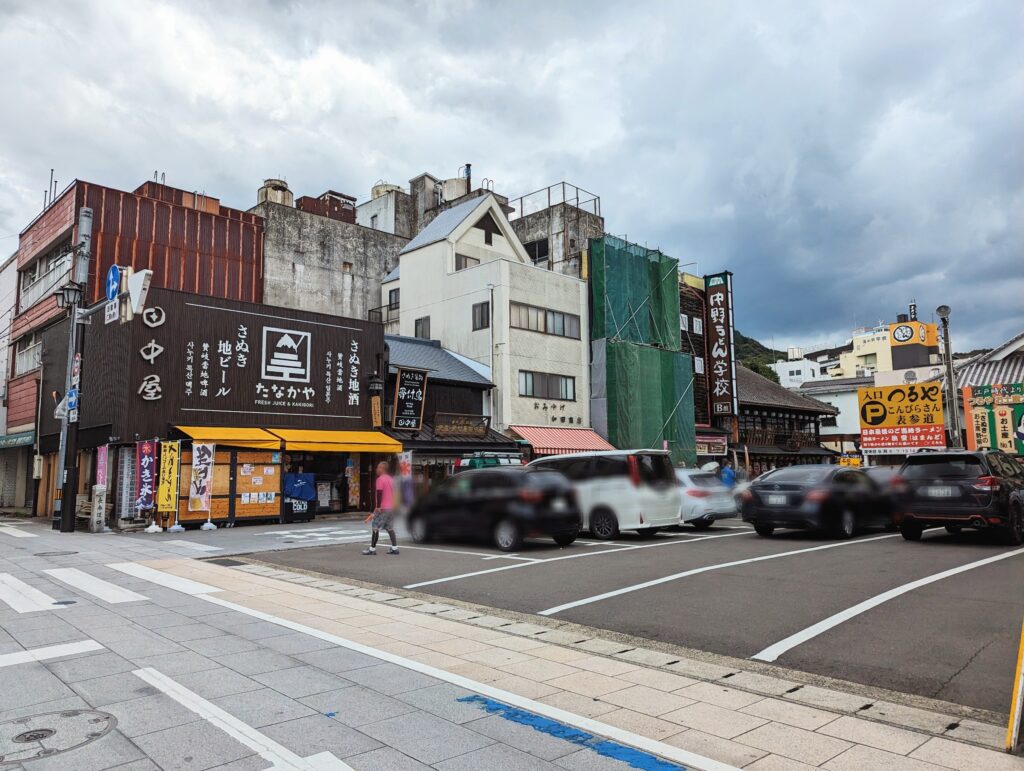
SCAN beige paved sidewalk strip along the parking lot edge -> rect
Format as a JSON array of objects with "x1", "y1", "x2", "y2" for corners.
[{"x1": 145, "y1": 559, "x2": 1024, "y2": 771}]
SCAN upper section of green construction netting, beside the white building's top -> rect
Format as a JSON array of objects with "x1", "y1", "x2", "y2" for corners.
[{"x1": 590, "y1": 235, "x2": 679, "y2": 350}]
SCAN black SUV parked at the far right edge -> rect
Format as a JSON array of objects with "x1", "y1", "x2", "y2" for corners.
[{"x1": 893, "y1": 449, "x2": 1024, "y2": 546}]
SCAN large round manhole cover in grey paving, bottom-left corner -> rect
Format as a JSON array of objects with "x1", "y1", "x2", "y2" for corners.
[{"x1": 0, "y1": 710, "x2": 118, "y2": 764}]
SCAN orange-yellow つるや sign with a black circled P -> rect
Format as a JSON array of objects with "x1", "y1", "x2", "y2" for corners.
[{"x1": 857, "y1": 383, "x2": 946, "y2": 455}]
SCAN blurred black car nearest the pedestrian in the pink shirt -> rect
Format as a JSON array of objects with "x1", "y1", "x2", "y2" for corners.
[{"x1": 409, "y1": 466, "x2": 581, "y2": 552}]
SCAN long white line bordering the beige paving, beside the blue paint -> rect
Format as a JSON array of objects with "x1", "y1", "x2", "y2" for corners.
[{"x1": 192, "y1": 594, "x2": 738, "y2": 771}]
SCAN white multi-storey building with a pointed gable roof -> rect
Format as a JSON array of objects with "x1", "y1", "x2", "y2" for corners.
[{"x1": 381, "y1": 196, "x2": 599, "y2": 449}]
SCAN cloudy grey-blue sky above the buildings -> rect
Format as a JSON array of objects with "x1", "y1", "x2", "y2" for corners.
[{"x1": 0, "y1": 0, "x2": 1024, "y2": 350}]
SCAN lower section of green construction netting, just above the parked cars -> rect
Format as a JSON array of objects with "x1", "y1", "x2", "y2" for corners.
[{"x1": 604, "y1": 340, "x2": 697, "y2": 468}]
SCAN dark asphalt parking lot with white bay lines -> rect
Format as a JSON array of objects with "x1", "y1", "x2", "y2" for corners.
[{"x1": 253, "y1": 520, "x2": 1024, "y2": 713}]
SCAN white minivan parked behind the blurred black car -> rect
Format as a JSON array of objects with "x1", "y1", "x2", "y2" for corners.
[{"x1": 529, "y1": 449, "x2": 682, "y2": 541}]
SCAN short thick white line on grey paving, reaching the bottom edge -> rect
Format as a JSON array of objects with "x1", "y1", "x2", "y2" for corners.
[{"x1": 132, "y1": 667, "x2": 351, "y2": 771}]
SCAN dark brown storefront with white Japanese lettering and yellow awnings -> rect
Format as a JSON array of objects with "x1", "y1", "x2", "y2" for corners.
[{"x1": 43, "y1": 290, "x2": 401, "y2": 525}]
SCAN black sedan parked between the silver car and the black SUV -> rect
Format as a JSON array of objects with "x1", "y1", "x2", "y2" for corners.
[{"x1": 743, "y1": 465, "x2": 892, "y2": 539}]
